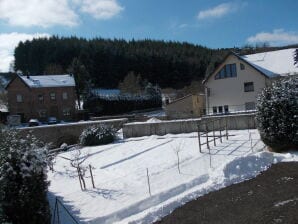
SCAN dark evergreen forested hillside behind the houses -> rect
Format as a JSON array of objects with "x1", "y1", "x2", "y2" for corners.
[{"x1": 14, "y1": 36, "x2": 293, "y2": 89}]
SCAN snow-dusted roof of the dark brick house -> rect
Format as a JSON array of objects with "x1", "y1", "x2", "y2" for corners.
[{"x1": 19, "y1": 75, "x2": 75, "y2": 88}]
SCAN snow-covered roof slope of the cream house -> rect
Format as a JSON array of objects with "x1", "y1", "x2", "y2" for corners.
[{"x1": 242, "y1": 48, "x2": 298, "y2": 77}]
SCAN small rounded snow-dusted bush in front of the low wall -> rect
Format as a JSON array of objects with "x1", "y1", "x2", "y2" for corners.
[{"x1": 80, "y1": 125, "x2": 116, "y2": 146}]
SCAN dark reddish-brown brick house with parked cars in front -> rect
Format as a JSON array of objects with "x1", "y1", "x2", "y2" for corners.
[{"x1": 6, "y1": 75, "x2": 76, "y2": 122}]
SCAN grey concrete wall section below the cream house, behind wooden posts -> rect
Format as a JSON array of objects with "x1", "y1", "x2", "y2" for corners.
[{"x1": 123, "y1": 113, "x2": 255, "y2": 138}]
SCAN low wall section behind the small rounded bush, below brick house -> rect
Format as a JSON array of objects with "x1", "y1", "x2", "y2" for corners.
[{"x1": 19, "y1": 118, "x2": 128, "y2": 148}]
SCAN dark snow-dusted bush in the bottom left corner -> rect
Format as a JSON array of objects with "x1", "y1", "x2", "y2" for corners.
[{"x1": 0, "y1": 130, "x2": 50, "y2": 224}]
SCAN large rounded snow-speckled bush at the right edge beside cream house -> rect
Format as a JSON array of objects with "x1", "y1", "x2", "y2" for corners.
[{"x1": 256, "y1": 77, "x2": 298, "y2": 152}]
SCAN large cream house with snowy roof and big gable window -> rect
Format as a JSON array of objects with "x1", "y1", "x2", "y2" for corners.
[{"x1": 203, "y1": 48, "x2": 298, "y2": 114}]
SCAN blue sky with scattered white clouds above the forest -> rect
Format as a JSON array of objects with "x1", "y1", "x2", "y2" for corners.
[{"x1": 0, "y1": 0, "x2": 298, "y2": 71}]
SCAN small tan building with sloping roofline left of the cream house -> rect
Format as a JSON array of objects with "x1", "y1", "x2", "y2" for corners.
[{"x1": 165, "y1": 94, "x2": 205, "y2": 119}]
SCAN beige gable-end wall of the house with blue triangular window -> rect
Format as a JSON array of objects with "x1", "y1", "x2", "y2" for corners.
[{"x1": 205, "y1": 55, "x2": 270, "y2": 114}]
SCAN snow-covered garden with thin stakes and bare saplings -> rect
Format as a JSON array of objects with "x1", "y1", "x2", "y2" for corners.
[{"x1": 48, "y1": 130, "x2": 298, "y2": 224}]
